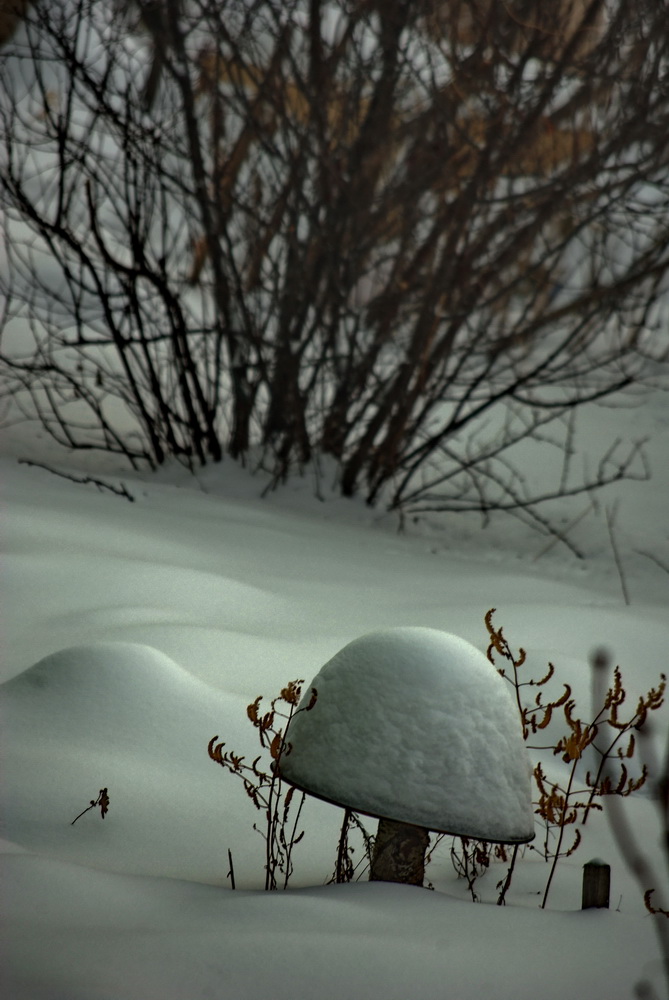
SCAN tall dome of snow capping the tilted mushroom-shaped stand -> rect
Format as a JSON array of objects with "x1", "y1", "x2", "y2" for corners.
[{"x1": 281, "y1": 627, "x2": 534, "y2": 843}]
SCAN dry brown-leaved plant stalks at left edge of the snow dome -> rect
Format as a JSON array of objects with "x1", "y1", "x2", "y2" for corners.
[{"x1": 208, "y1": 680, "x2": 317, "y2": 890}]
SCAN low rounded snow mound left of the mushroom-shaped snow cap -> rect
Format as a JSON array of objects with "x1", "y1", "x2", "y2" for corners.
[{"x1": 0, "y1": 642, "x2": 254, "y2": 881}]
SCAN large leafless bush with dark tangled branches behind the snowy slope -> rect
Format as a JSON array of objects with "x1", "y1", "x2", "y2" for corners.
[{"x1": 0, "y1": 0, "x2": 669, "y2": 532}]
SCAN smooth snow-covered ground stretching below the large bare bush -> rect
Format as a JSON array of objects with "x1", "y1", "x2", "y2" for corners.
[{"x1": 0, "y1": 384, "x2": 669, "y2": 1000}]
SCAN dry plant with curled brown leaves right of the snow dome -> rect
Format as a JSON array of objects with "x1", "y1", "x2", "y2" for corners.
[{"x1": 485, "y1": 608, "x2": 666, "y2": 907}]
